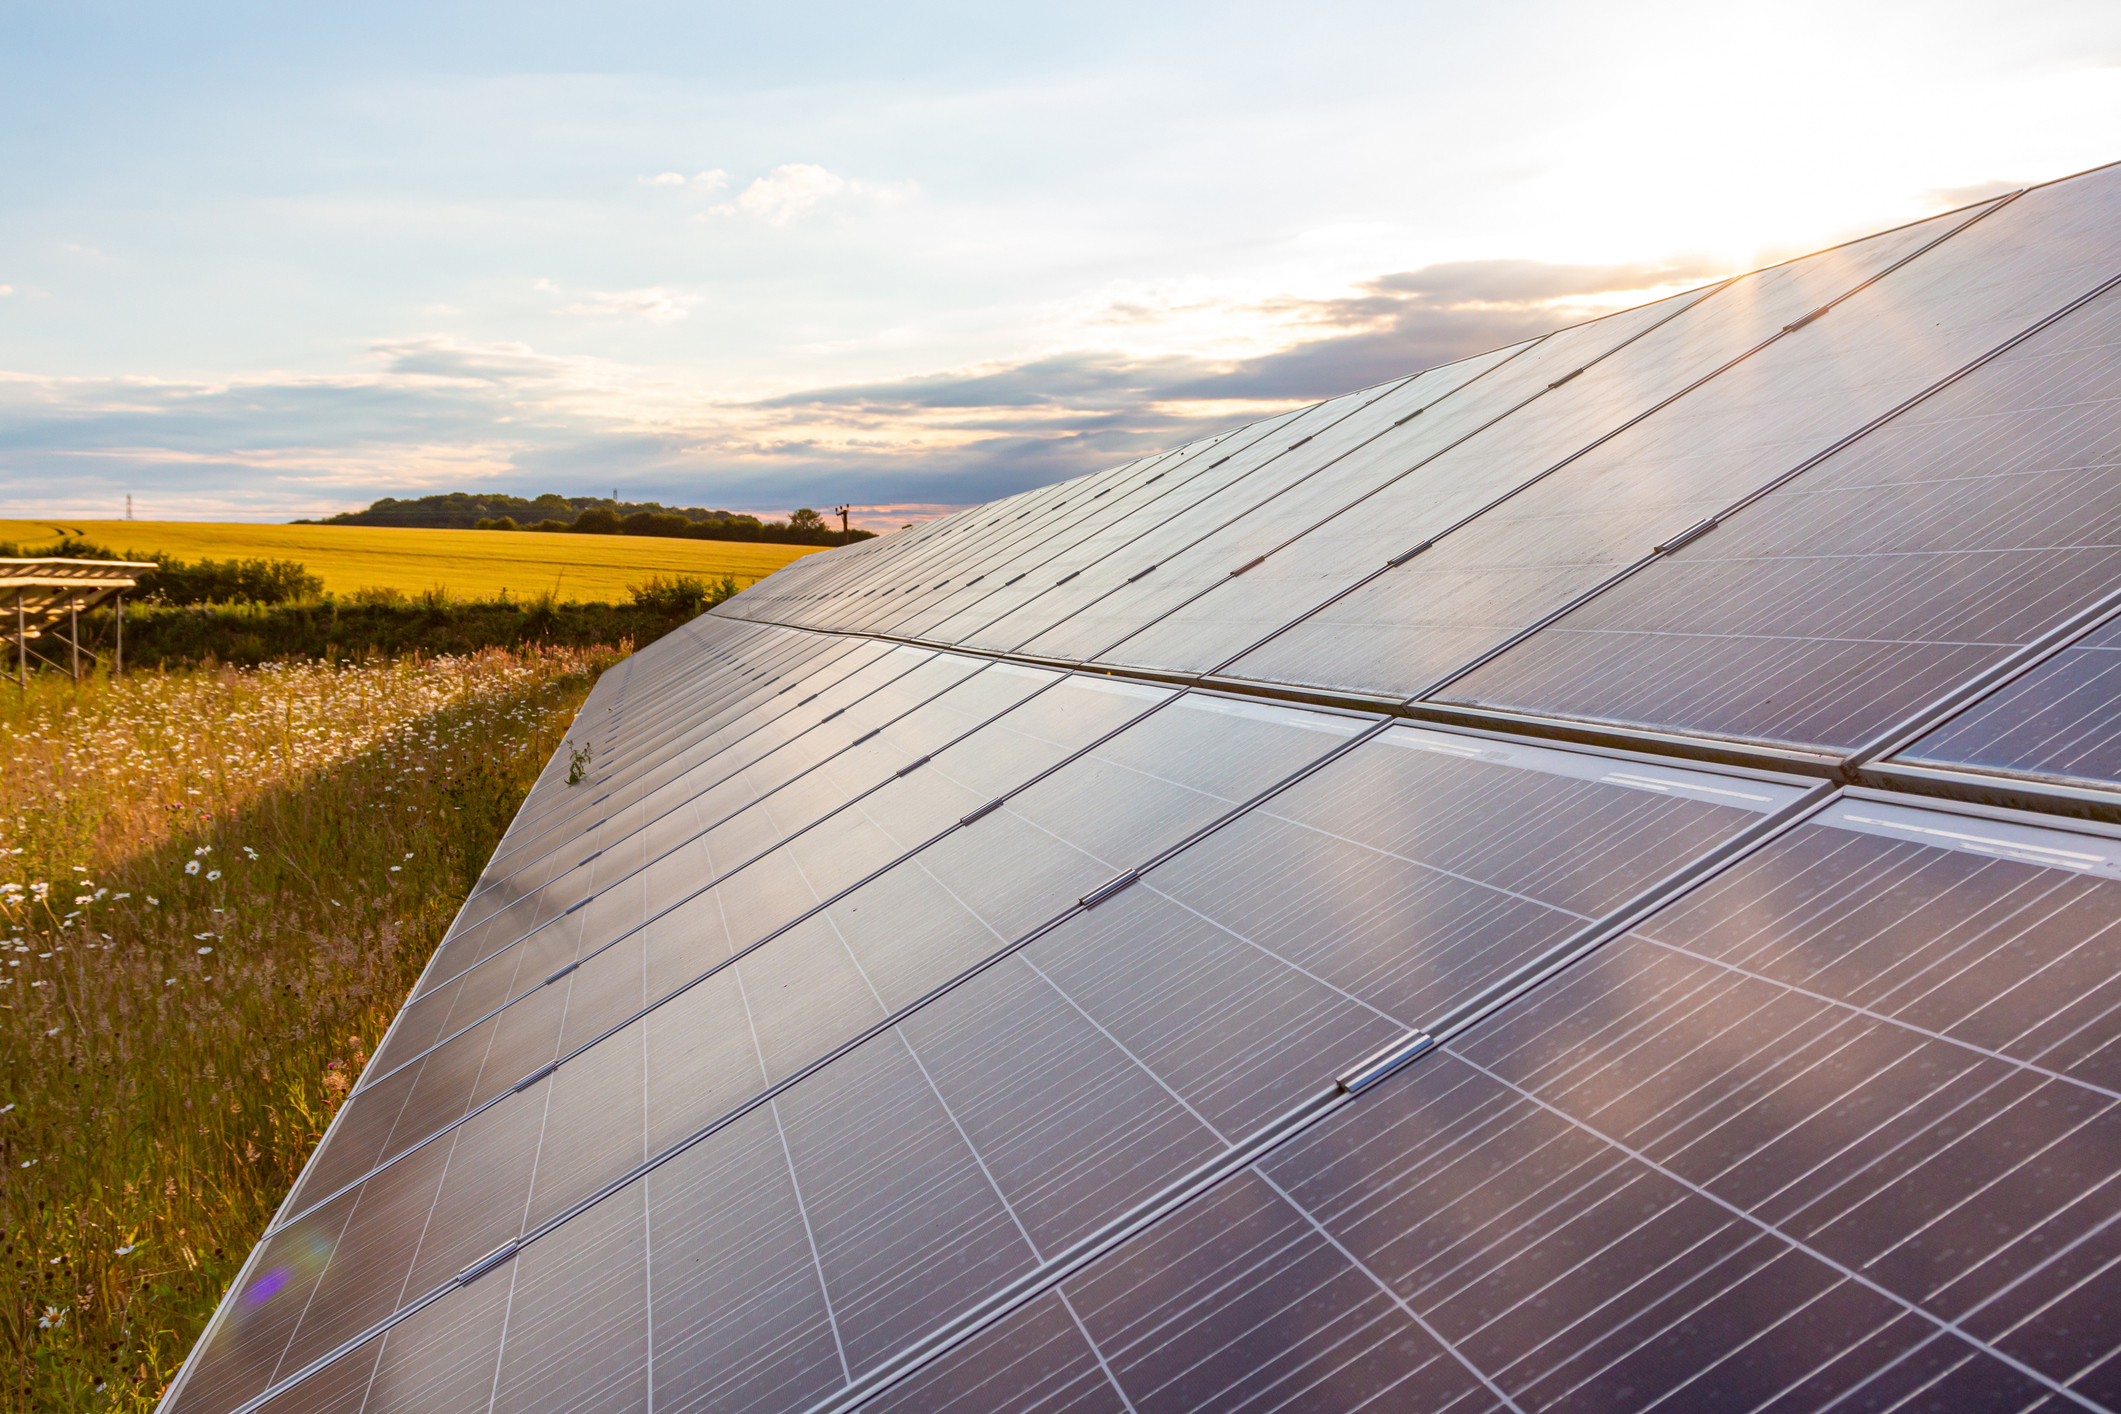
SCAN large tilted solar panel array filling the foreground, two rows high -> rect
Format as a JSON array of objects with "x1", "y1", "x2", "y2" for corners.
[{"x1": 165, "y1": 167, "x2": 2121, "y2": 1414}]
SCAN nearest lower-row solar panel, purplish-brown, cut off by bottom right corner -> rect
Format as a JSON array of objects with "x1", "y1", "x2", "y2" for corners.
[{"x1": 867, "y1": 801, "x2": 2121, "y2": 1412}]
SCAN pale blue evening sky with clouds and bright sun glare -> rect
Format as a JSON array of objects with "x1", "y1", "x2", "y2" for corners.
[{"x1": 0, "y1": 0, "x2": 2121, "y2": 528}]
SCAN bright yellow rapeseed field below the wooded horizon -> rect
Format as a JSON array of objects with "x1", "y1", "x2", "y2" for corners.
[{"x1": 0, "y1": 519, "x2": 814, "y2": 604}]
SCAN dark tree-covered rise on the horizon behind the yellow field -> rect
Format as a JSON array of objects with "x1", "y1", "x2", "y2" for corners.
[{"x1": 295, "y1": 492, "x2": 874, "y2": 545}]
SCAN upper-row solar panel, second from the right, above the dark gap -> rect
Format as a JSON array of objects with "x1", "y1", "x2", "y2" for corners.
[{"x1": 1444, "y1": 279, "x2": 2121, "y2": 750}]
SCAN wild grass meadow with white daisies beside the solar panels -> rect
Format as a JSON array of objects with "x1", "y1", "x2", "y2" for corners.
[{"x1": 0, "y1": 649, "x2": 619, "y2": 1410}]
